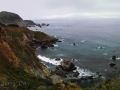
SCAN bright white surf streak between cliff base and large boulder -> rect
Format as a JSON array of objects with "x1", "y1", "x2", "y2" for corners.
[{"x1": 38, "y1": 55, "x2": 62, "y2": 65}]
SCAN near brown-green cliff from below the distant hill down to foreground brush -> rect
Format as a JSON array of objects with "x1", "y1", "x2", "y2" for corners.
[{"x1": 0, "y1": 26, "x2": 53, "y2": 90}]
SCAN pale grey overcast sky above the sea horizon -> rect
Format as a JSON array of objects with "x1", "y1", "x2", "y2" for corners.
[{"x1": 0, "y1": 0, "x2": 120, "y2": 19}]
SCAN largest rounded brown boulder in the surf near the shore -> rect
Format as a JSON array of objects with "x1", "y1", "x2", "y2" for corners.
[{"x1": 61, "y1": 59, "x2": 77, "y2": 71}]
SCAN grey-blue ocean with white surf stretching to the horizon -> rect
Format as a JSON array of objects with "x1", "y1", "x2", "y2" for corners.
[{"x1": 29, "y1": 19, "x2": 120, "y2": 87}]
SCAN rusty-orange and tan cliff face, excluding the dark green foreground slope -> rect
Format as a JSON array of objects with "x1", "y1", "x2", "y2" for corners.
[{"x1": 0, "y1": 26, "x2": 51, "y2": 77}]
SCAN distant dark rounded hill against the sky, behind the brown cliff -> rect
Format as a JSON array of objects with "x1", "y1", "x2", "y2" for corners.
[{"x1": 0, "y1": 11, "x2": 35, "y2": 27}]
